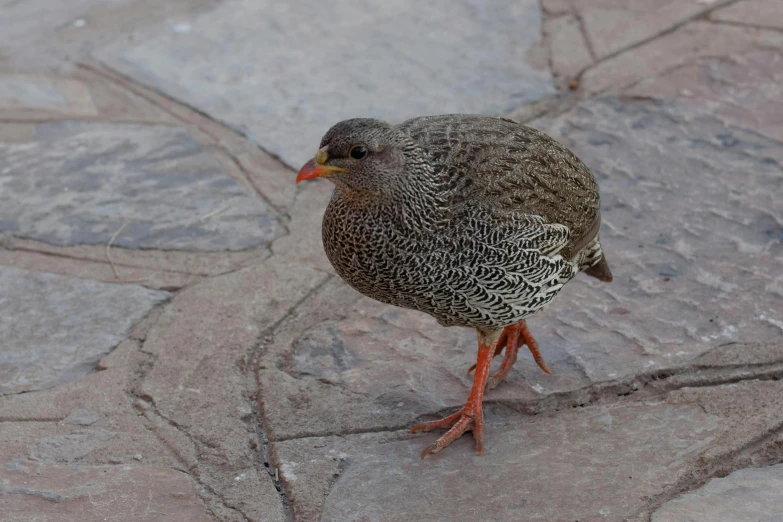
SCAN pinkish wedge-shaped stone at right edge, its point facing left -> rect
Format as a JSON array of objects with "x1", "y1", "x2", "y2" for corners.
[{"x1": 626, "y1": 49, "x2": 783, "y2": 141}]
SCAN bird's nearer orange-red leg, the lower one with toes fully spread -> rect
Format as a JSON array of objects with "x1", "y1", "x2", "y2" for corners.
[{"x1": 411, "y1": 336, "x2": 496, "y2": 458}]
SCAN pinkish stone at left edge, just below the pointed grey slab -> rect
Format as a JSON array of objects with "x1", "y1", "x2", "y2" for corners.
[{"x1": 0, "y1": 341, "x2": 180, "y2": 470}]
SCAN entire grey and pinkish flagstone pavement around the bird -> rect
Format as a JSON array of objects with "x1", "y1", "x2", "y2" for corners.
[{"x1": 0, "y1": 0, "x2": 783, "y2": 522}]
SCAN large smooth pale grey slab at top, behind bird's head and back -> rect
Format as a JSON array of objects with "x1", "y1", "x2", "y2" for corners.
[{"x1": 98, "y1": 0, "x2": 554, "y2": 167}]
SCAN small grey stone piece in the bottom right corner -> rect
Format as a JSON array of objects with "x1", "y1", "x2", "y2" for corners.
[{"x1": 652, "y1": 464, "x2": 783, "y2": 522}]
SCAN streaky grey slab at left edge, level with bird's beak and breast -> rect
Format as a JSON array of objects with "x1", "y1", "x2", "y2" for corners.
[{"x1": 0, "y1": 123, "x2": 278, "y2": 250}]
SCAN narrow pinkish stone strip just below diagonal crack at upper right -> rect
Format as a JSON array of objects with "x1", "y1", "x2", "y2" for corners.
[{"x1": 582, "y1": 21, "x2": 783, "y2": 95}]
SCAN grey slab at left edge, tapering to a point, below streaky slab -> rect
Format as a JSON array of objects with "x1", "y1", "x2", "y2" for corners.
[{"x1": 0, "y1": 267, "x2": 169, "y2": 393}]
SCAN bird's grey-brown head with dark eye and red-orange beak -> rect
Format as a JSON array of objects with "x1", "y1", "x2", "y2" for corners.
[{"x1": 296, "y1": 118, "x2": 413, "y2": 194}]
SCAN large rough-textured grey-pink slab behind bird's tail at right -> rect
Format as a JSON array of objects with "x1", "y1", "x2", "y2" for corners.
[{"x1": 539, "y1": 99, "x2": 783, "y2": 380}]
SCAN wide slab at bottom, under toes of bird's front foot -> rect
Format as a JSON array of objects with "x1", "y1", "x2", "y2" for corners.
[{"x1": 272, "y1": 403, "x2": 724, "y2": 522}]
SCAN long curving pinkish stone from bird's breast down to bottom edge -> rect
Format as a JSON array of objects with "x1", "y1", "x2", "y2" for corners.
[{"x1": 116, "y1": 183, "x2": 331, "y2": 521}]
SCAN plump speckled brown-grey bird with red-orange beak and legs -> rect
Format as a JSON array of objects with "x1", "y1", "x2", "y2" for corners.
[{"x1": 296, "y1": 114, "x2": 612, "y2": 458}]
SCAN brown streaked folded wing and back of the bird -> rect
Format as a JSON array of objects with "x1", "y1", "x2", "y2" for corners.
[{"x1": 398, "y1": 114, "x2": 600, "y2": 258}]
